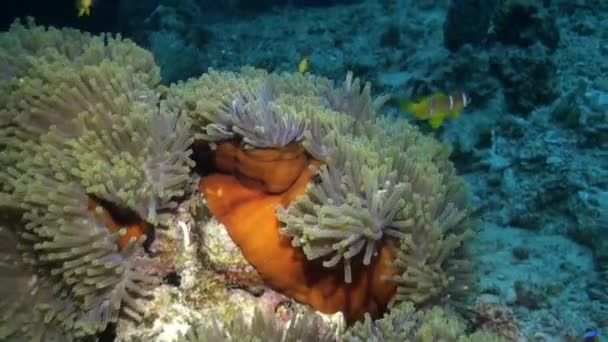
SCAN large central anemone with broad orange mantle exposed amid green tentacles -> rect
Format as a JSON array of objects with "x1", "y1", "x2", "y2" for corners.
[{"x1": 195, "y1": 69, "x2": 471, "y2": 320}]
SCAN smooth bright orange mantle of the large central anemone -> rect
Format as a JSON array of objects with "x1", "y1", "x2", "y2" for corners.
[{"x1": 199, "y1": 142, "x2": 395, "y2": 322}]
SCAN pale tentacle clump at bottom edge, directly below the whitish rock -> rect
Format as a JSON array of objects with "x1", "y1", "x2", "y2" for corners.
[{"x1": 177, "y1": 307, "x2": 334, "y2": 342}]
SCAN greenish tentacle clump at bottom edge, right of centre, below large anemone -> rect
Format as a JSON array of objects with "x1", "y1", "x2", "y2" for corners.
[{"x1": 344, "y1": 302, "x2": 506, "y2": 342}]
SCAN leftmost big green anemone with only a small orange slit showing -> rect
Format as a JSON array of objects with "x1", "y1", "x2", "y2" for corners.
[{"x1": 0, "y1": 18, "x2": 192, "y2": 337}]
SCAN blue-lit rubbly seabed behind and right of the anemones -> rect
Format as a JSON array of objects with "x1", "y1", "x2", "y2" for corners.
[{"x1": 108, "y1": 0, "x2": 608, "y2": 340}]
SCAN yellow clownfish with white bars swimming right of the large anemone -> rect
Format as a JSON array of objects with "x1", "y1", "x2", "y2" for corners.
[{"x1": 401, "y1": 92, "x2": 471, "y2": 128}]
